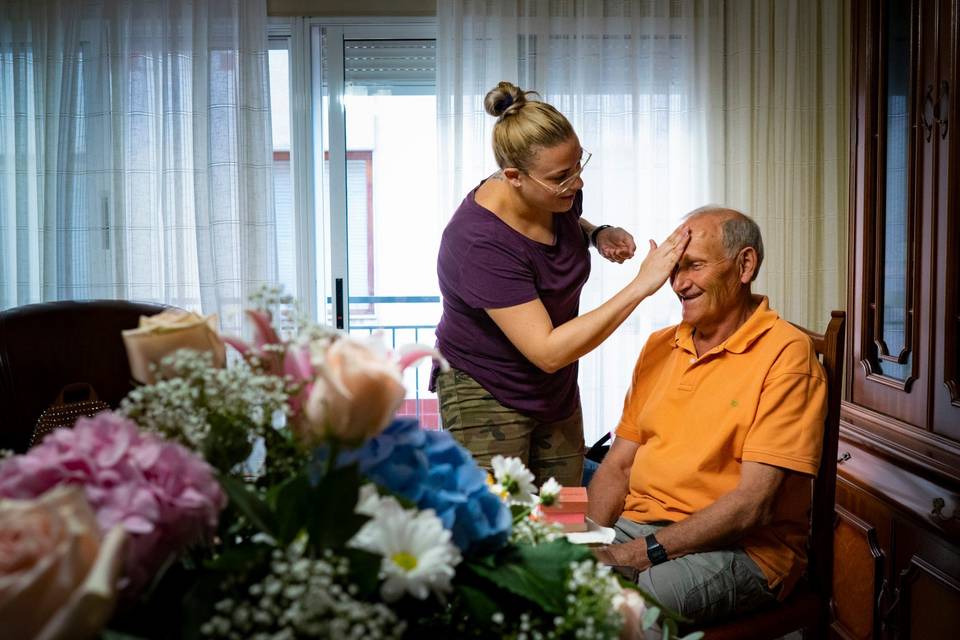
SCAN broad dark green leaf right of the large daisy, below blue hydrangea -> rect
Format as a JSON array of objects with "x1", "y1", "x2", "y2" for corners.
[{"x1": 466, "y1": 540, "x2": 592, "y2": 615}]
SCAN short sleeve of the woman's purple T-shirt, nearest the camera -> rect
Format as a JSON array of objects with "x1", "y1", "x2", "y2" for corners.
[{"x1": 460, "y1": 240, "x2": 540, "y2": 309}]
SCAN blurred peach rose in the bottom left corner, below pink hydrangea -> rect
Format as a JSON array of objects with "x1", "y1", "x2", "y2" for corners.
[{"x1": 0, "y1": 485, "x2": 124, "y2": 640}]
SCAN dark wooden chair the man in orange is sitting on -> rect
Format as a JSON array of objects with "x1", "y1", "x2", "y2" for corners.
[{"x1": 701, "y1": 311, "x2": 846, "y2": 640}]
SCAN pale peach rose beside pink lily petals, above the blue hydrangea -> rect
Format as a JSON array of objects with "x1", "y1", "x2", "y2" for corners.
[{"x1": 294, "y1": 338, "x2": 405, "y2": 444}]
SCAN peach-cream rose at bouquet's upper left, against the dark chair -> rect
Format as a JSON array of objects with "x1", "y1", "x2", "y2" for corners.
[{"x1": 123, "y1": 309, "x2": 227, "y2": 384}]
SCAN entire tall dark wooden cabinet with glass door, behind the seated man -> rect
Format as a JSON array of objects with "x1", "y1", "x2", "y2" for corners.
[{"x1": 833, "y1": 0, "x2": 960, "y2": 638}]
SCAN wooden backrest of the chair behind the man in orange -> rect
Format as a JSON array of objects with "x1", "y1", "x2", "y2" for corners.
[{"x1": 794, "y1": 311, "x2": 847, "y2": 597}]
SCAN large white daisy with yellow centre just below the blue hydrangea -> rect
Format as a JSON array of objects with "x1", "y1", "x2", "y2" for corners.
[{"x1": 347, "y1": 492, "x2": 460, "y2": 602}]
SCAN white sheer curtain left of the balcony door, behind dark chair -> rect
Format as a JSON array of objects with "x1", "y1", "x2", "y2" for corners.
[{"x1": 0, "y1": 0, "x2": 277, "y2": 331}]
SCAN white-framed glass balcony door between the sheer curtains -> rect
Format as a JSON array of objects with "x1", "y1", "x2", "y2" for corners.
[{"x1": 311, "y1": 24, "x2": 447, "y2": 427}]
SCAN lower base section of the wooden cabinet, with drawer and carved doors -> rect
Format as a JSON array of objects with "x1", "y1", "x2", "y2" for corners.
[{"x1": 833, "y1": 442, "x2": 960, "y2": 640}]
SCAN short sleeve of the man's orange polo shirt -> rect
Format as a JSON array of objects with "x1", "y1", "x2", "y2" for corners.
[{"x1": 743, "y1": 341, "x2": 827, "y2": 475}]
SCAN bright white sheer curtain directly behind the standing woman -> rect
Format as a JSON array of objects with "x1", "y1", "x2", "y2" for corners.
[{"x1": 437, "y1": 0, "x2": 723, "y2": 444}]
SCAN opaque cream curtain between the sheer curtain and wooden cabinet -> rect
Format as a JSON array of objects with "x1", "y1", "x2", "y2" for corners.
[{"x1": 716, "y1": 0, "x2": 851, "y2": 331}]
